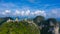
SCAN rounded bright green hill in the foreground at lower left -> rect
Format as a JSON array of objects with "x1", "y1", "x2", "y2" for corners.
[{"x1": 0, "y1": 21, "x2": 40, "y2": 34}]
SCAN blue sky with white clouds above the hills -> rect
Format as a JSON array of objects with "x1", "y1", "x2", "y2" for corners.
[{"x1": 0, "y1": 0, "x2": 60, "y2": 18}]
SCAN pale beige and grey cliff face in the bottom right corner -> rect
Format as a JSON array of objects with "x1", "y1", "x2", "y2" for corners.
[{"x1": 48, "y1": 22, "x2": 59, "y2": 34}]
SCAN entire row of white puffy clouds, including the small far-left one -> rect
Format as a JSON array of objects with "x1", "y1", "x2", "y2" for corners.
[{"x1": 2, "y1": 10, "x2": 46, "y2": 16}]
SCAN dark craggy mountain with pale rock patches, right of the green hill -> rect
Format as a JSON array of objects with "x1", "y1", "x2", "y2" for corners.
[{"x1": 33, "y1": 16, "x2": 59, "y2": 34}]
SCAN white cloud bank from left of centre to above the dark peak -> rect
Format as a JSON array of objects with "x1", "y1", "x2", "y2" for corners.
[{"x1": 14, "y1": 10, "x2": 46, "y2": 16}]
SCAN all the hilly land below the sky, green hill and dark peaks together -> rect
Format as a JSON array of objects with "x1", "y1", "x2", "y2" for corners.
[{"x1": 0, "y1": 16, "x2": 60, "y2": 34}]
